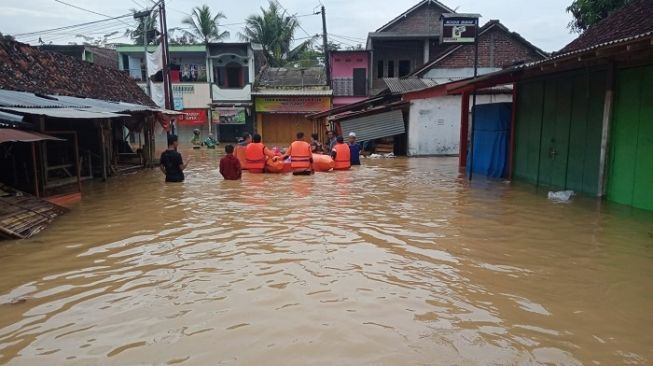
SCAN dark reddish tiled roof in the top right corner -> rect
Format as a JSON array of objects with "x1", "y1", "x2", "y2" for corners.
[{"x1": 559, "y1": 0, "x2": 653, "y2": 53}]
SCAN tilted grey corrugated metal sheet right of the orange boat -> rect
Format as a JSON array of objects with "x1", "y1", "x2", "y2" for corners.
[{"x1": 340, "y1": 110, "x2": 406, "y2": 141}]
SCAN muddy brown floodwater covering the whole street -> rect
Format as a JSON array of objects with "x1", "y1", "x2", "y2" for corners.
[{"x1": 0, "y1": 151, "x2": 653, "y2": 365}]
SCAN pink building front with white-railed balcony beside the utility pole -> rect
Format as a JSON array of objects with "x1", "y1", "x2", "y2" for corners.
[{"x1": 329, "y1": 50, "x2": 370, "y2": 107}]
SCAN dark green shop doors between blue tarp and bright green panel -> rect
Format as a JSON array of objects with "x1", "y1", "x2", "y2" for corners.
[{"x1": 513, "y1": 70, "x2": 607, "y2": 195}]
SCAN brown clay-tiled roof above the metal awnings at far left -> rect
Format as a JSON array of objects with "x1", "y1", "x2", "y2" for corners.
[{"x1": 0, "y1": 40, "x2": 155, "y2": 106}]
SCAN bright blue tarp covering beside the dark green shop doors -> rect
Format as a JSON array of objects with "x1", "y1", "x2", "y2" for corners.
[{"x1": 467, "y1": 103, "x2": 512, "y2": 178}]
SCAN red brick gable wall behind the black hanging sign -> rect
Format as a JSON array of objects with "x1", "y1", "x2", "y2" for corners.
[{"x1": 435, "y1": 28, "x2": 542, "y2": 68}]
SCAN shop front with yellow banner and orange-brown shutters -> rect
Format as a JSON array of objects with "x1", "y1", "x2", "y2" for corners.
[{"x1": 254, "y1": 91, "x2": 331, "y2": 145}]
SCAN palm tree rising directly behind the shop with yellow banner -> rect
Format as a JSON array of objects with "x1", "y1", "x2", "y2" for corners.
[{"x1": 241, "y1": 0, "x2": 306, "y2": 66}]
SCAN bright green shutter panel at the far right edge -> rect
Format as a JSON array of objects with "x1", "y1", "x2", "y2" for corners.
[{"x1": 608, "y1": 65, "x2": 653, "y2": 210}]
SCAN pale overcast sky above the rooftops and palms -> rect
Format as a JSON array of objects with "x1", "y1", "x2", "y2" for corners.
[{"x1": 0, "y1": 0, "x2": 575, "y2": 51}]
